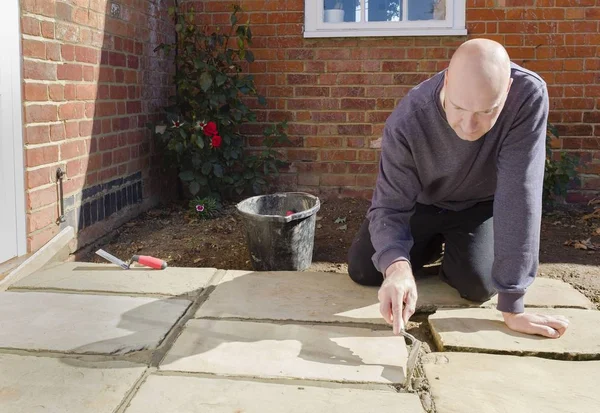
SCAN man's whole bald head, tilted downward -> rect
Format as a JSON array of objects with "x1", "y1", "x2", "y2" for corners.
[{"x1": 441, "y1": 39, "x2": 512, "y2": 141}]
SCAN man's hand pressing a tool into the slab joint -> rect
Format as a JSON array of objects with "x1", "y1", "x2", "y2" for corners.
[{"x1": 377, "y1": 261, "x2": 417, "y2": 334}]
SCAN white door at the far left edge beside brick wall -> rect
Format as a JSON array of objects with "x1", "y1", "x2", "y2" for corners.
[{"x1": 0, "y1": 0, "x2": 26, "y2": 263}]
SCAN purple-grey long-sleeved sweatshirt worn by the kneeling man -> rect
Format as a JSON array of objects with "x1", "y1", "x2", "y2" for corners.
[{"x1": 367, "y1": 64, "x2": 549, "y2": 313}]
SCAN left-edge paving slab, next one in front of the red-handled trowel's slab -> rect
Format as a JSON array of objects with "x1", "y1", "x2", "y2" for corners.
[{"x1": 0, "y1": 292, "x2": 191, "y2": 354}]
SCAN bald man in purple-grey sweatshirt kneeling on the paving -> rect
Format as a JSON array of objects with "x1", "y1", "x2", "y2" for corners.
[{"x1": 348, "y1": 39, "x2": 568, "y2": 338}]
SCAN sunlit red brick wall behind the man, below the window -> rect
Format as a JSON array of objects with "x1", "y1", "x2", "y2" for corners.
[{"x1": 189, "y1": 0, "x2": 600, "y2": 201}]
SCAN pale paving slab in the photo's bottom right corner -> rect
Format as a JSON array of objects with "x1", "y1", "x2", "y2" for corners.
[{"x1": 423, "y1": 353, "x2": 600, "y2": 413}]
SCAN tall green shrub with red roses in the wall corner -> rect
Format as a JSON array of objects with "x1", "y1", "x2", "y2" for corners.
[{"x1": 150, "y1": 6, "x2": 289, "y2": 199}]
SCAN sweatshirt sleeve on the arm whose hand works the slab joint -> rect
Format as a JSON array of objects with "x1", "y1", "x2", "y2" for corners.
[{"x1": 367, "y1": 122, "x2": 421, "y2": 275}]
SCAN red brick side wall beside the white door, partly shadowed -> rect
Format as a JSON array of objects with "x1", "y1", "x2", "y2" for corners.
[{"x1": 21, "y1": 0, "x2": 174, "y2": 251}]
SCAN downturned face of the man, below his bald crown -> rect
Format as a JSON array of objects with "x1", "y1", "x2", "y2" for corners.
[{"x1": 443, "y1": 73, "x2": 512, "y2": 141}]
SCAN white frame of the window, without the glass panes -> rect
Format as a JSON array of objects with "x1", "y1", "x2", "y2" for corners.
[{"x1": 304, "y1": 0, "x2": 467, "y2": 38}]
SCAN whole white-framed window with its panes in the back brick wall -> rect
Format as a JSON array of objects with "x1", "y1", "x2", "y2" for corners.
[{"x1": 304, "y1": 0, "x2": 467, "y2": 37}]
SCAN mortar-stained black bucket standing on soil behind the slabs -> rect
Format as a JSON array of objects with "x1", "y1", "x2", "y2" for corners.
[{"x1": 236, "y1": 192, "x2": 321, "y2": 271}]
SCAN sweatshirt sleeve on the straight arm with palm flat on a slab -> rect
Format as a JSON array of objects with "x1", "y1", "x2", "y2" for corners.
[{"x1": 492, "y1": 84, "x2": 549, "y2": 313}]
